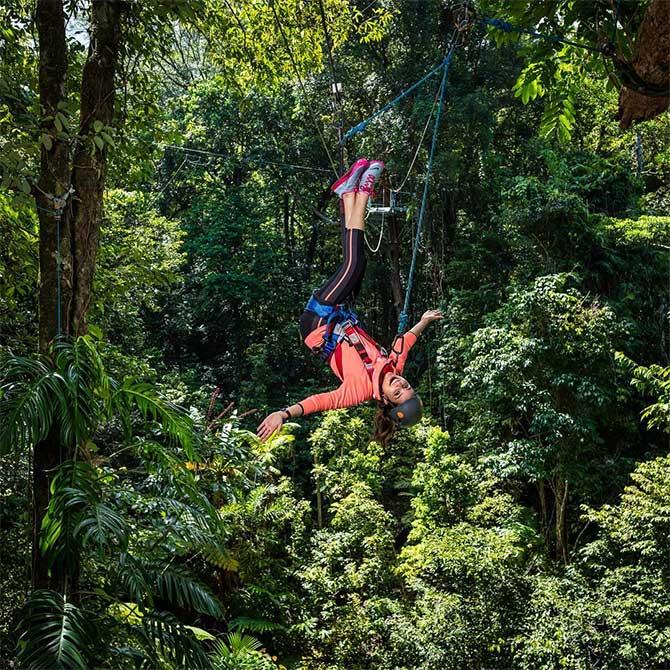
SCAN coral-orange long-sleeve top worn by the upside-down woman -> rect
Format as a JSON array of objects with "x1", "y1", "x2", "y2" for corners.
[{"x1": 300, "y1": 325, "x2": 416, "y2": 414}]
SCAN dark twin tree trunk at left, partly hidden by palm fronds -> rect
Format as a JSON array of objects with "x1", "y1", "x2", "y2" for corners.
[{"x1": 32, "y1": 0, "x2": 123, "y2": 590}]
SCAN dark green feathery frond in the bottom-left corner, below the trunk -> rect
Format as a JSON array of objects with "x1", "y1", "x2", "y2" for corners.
[{"x1": 19, "y1": 590, "x2": 90, "y2": 670}]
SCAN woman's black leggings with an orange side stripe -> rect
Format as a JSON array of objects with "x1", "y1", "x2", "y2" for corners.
[{"x1": 300, "y1": 227, "x2": 367, "y2": 340}]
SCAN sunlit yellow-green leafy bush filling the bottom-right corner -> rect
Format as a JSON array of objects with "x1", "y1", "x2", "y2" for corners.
[{"x1": 515, "y1": 457, "x2": 670, "y2": 670}]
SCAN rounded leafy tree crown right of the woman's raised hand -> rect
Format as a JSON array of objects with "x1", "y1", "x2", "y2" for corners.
[{"x1": 462, "y1": 276, "x2": 617, "y2": 480}]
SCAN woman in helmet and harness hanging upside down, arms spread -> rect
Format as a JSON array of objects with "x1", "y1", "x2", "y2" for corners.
[{"x1": 258, "y1": 158, "x2": 442, "y2": 444}]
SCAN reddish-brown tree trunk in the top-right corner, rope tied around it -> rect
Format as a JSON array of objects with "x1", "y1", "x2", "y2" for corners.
[{"x1": 618, "y1": 0, "x2": 670, "y2": 129}]
